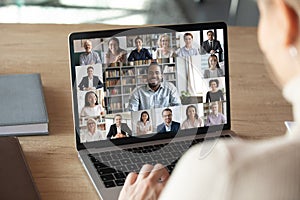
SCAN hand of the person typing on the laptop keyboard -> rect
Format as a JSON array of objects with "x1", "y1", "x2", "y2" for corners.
[{"x1": 119, "y1": 164, "x2": 169, "y2": 200}]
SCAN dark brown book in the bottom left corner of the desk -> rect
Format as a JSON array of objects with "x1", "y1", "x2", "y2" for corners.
[{"x1": 0, "y1": 137, "x2": 41, "y2": 200}]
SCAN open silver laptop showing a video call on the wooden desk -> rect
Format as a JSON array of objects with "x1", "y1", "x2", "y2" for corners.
[{"x1": 69, "y1": 22, "x2": 234, "y2": 200}]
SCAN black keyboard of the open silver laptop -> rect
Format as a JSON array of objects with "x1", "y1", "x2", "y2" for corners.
[{"x1": 88, "y1": 136, "x2": 229, "y2": 188}]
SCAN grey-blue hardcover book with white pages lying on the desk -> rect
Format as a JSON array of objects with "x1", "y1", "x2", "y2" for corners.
[{"x1": 0, "y1": 74, "x2": 49, "y2": 136}]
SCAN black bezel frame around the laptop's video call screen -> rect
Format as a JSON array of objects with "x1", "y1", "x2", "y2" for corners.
[{"x1": 69, "y1": 22, "x2": 231, "y2": 151}]
